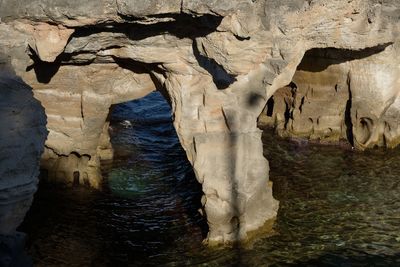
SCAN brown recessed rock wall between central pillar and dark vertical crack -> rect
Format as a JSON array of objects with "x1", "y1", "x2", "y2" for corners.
[{"x1": 259, "y1": 49, "x2": 352, "y2": 147}]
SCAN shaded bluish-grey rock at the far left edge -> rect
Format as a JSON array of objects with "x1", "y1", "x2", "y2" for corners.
[{"x1": 0, "y1": 66, "x2": 47, "y2": 266}]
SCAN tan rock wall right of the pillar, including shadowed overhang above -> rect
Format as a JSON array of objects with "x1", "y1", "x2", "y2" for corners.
[{"x1": 259, "y1": 45, "x2": 400, "y2": 150}]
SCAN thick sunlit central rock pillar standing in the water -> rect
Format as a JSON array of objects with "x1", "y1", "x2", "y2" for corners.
[{"x1": 165, "y1": 75, "x2": 278, "y2": 243}]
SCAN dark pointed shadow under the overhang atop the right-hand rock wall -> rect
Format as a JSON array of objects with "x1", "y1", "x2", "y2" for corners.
[{"x1": 297, "y1": 43, "x2": 393, "y2": 72}]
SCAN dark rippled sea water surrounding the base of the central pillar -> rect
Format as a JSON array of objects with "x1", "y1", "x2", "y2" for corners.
[{"x1": 21, "y1": 93, "x2": 400, "y2": 266}]
